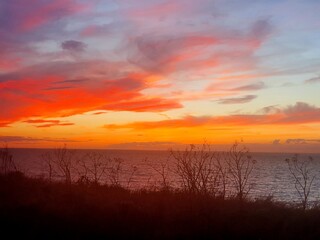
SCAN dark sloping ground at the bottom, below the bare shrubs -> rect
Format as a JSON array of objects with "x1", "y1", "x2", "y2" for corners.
[{"x1": 0, "y1": 172, "x2": 320, "y2": 239}]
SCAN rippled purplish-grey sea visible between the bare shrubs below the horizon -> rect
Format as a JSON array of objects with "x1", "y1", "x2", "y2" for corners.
[{"x1": 6, "y1": 149, "x2": 320, "y2": 202}]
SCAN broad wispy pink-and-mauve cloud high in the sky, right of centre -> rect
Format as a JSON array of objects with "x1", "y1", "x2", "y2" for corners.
[{"x1": 125, "y1": 20, "x2": 273, "y2": 78}]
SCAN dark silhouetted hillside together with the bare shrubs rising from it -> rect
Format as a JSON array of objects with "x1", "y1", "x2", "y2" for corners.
[{"x1": 0, "y1": 144, "x2": 320, "y2": 239}]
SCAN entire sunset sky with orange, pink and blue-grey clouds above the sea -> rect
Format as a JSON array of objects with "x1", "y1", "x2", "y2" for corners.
[{"x1": 0, "y1": 0, "x2": 320, "y2": 152}]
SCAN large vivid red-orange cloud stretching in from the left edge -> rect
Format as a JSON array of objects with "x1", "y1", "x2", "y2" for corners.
[{"x1": 0, "y1": 62, "x2": 182, "y2": 126}]
